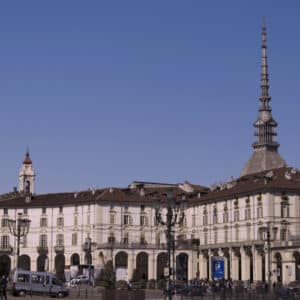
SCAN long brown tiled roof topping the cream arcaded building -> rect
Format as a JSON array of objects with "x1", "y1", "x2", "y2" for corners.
[{"x1": 0, "y1": 167, "x2": 300, "y2": 208}]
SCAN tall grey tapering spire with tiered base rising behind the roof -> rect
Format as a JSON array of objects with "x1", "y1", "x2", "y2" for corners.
[{"x1": 241, "y1": 20, "x2": 286, "y2": 176}]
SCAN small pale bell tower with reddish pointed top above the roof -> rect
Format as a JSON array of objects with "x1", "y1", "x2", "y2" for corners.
[{"x1": 19, "y1": 149, "x2": 35, "y2": 194}]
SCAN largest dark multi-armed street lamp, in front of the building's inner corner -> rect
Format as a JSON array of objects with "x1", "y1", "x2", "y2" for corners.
[{"x1": 155, "y1": 192, "x2": 185, "y2": 300}]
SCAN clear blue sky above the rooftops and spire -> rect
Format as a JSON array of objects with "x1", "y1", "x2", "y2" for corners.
[{"x1": 0, "y1": 0, "x2": 300, "y2": 193}]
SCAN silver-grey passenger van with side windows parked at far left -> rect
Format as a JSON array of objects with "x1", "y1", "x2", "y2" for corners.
[{"x1": 12, "y1": 269, "x2": 69, "y2": 298}]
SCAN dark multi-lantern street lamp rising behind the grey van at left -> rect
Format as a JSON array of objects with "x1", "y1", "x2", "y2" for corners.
[{"x1": 8, "y1": 213, "x2": 31, "y2": 268}]
